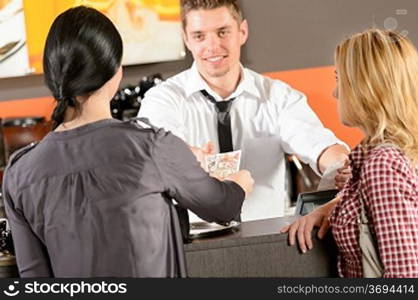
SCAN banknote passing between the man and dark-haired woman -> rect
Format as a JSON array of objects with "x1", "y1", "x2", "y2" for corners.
[{"x1": 206, "y1": 150, "x2": 241, "y2": 178}]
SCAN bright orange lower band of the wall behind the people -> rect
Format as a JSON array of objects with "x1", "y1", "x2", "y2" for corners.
[{"x1": 0, "y1": 67, "x2": 363, "y2": 147}]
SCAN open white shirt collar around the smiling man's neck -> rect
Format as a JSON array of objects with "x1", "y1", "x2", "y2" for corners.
[{"x1": 185, "y1": 62, "x2": 260, "y2": 101}]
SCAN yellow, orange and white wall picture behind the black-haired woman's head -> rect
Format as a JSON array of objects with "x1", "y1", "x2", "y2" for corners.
[{"x1": 0, "y1": 0, "x2": 185, "y2": 77}]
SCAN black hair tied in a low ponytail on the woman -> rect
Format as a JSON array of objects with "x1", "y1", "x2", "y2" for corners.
[{"x1": 43, "y1": 6, "x2": 123, "y2": 129}]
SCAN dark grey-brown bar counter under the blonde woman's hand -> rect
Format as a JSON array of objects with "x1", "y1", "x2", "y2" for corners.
[{"x1": 185, "y1": 217, "x2": 337, "y2": 278}]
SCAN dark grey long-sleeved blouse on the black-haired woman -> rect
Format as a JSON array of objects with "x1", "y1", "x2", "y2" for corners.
[{"x1": 3, "y1": 119, "x2": 244, "y2": 277}]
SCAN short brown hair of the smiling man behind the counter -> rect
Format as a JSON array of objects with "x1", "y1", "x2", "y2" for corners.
[{"x1": 180, "y1": 0, "x2": 244, "y2": 29}]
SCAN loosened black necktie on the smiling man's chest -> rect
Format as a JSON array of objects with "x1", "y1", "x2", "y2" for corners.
[{"x1": 201, "y1": 90, "x2": 235, "y2": 153}]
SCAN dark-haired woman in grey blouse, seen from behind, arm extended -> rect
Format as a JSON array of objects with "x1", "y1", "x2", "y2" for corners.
[{"x1": 4, "y1": 7, "x2": 252, "y2": 277}]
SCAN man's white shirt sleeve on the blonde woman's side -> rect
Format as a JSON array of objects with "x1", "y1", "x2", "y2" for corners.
[{"x1": 273, "y1": 86, "x2": 349, "y2": 174}]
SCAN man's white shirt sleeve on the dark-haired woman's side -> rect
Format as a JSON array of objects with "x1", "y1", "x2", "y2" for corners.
[{"x1": 138, "y1": 82, "x2": 186, "y2": 140}]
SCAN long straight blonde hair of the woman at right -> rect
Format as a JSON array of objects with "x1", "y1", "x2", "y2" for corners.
[{"x1": 335, "y1": 29, "x2": 418, "y2": 166}]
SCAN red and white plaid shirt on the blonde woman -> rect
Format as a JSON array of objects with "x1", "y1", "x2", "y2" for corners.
[{"x1": 330, "y1": 145, "x2": 418, "y2": 277}]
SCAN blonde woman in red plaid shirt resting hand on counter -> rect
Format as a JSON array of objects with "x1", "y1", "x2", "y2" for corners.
[{"x1": 282, "y1": 29, "x2": 418, "y2": 277}]
